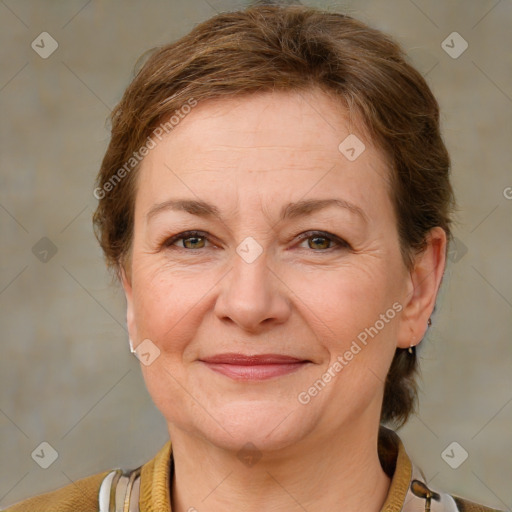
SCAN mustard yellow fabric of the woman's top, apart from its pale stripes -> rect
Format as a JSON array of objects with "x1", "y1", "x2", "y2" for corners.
[{"x1": 5, "y1": 427, "x2": 499, "y2": 512}]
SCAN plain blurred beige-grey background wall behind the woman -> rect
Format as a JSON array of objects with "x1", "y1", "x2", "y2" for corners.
[{"x1": 0, "y1": 0, "x2": 512, "y2": 510}]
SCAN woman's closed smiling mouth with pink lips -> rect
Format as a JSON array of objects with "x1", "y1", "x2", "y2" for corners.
[{"x1": 200, "y1": 353, "x2": 311, "y2": 381}]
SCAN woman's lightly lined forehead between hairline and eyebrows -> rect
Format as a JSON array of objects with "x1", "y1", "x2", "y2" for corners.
[{"x1": 136, "y1": 90, "x2": 388, "y2": 222}]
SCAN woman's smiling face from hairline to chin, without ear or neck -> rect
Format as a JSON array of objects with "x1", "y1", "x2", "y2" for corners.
[{"x1": 123, "y1": 91, "x2": 428, "y2": 449}]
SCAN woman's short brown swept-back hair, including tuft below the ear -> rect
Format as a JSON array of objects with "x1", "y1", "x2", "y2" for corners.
[{"x1": 93, "y1": 5, "x2": 455, "y2": 426}]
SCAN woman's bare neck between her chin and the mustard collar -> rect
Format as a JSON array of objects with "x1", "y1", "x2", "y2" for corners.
[{"x1": 170, "y1": 425, "x2": 390, "y2": 512}]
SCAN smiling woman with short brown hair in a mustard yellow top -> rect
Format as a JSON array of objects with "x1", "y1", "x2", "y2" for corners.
[{"x1": 3, "y1": 6, "x2": 504, "y2": 512}]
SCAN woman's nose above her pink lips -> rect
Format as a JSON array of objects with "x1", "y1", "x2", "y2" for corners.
[{"x1": 215, "y1": 243, "x2": 291, "y2": 332}]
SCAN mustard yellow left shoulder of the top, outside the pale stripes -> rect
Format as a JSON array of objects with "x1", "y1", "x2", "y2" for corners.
[{"x1": 3, "y1": 471, "x2": 109, "y2": 512}]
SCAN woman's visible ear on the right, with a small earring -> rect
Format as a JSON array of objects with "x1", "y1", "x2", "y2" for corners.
[{"x1": 397, "y1": 227, "x2": 447, "y2": 348}]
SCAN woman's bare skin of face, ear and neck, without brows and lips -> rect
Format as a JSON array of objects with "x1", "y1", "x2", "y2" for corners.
[{"x1": 122, "y1": 90, "x2": 446, "y2": 512}]
